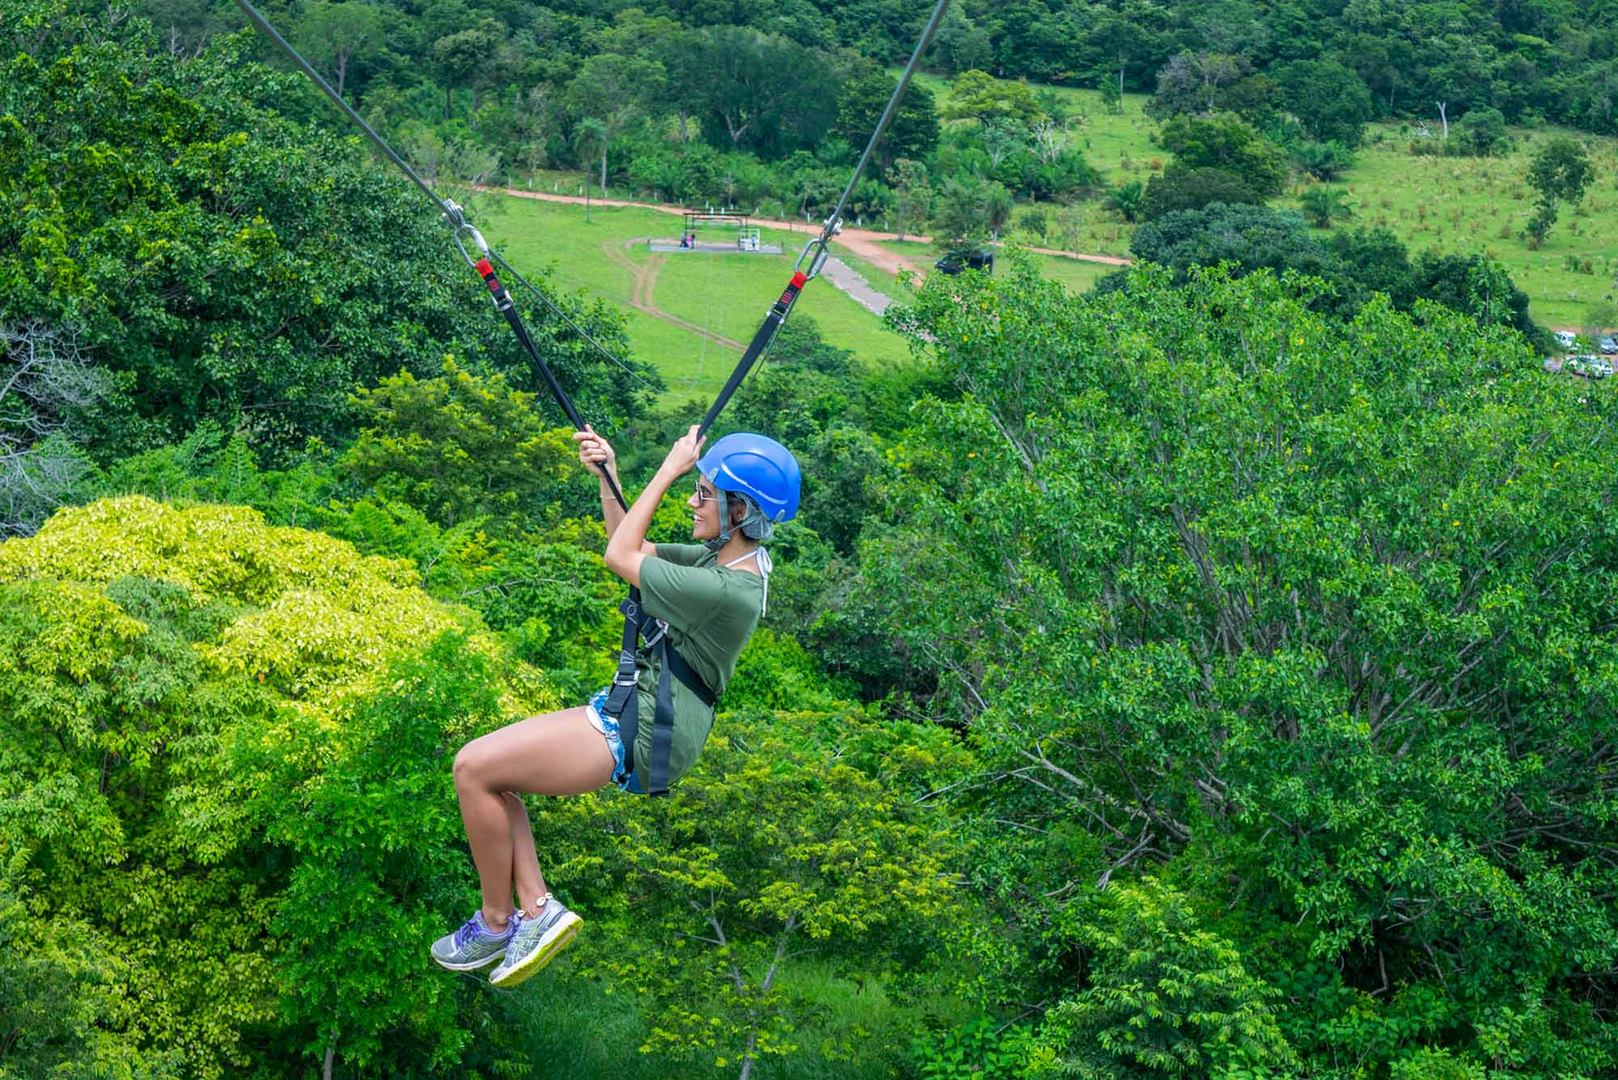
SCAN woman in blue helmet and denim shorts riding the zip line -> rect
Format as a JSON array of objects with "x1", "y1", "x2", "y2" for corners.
[{"x1": 432, "y1": 426, "x2": 799, "y2": 986}]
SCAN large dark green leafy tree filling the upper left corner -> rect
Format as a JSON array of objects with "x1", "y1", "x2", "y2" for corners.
[{"x1": 0, "y1": 3, "x2": 644, "y2": 461}]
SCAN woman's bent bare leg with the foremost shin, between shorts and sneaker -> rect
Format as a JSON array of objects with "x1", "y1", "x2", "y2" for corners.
[{"x1": 455, "y1": 706, "x2": 613, "y2": 931}]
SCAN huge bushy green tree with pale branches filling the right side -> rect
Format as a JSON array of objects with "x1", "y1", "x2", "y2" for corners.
[{"x1": 880, "y1": 264, "x2": 1618, "y2": 1075}]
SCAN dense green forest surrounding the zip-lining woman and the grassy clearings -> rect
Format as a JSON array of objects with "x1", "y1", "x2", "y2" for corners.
[{"x1": 0, "y1": 0, "x2": 1618, "y2": 1080}]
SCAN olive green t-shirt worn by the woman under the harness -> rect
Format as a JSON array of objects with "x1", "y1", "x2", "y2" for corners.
[{"x1": 634, "y1": 544, "x2": 764, "y2": 784}]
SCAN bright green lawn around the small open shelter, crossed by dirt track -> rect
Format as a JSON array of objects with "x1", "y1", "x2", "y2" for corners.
[{"x1": 479, "y1": 196, "x2": 908, "y2": 398}]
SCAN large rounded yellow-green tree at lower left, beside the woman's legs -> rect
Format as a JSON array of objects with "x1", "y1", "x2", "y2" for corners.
[{"x1": 0, "y1": 497, "x2": 557, "y2": 1077}]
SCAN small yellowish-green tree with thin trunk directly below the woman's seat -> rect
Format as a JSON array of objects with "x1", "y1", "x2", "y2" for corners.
[{"x1": 556, "y1": 702, "x2": 951, "y2": 1077}]
